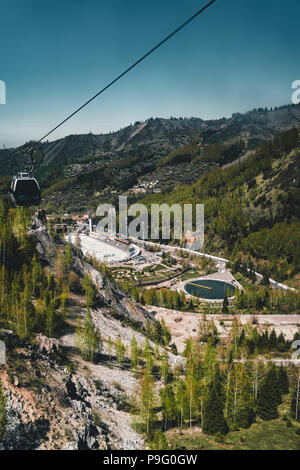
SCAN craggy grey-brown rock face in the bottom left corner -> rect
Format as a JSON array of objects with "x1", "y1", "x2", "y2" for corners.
[{"x1": 0, "y1": 333, "x2": 144, "y2": 450}]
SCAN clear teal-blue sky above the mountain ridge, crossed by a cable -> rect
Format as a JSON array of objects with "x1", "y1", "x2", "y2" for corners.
[{"x1": 0, "y1": 0, "x2": 300, "y2": 147}]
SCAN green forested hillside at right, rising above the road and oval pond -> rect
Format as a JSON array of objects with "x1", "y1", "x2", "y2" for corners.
[{"x1": 138, "y1": 129, "x2": 300, "y2": 280}]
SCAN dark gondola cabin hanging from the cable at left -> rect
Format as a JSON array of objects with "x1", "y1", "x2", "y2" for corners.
[{"x1": 10, "y1": 173, "x2": 41, "y2": 206}]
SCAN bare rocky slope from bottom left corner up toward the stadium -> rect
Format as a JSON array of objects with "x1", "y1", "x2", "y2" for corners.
[{"x1": 0, "y1": 218, "x2": 176, "y2": 450}]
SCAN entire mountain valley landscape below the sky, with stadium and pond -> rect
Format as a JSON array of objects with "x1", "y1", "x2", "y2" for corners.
[{"x1": 0, "y1": 107, "x2": 300, "y2": 450}]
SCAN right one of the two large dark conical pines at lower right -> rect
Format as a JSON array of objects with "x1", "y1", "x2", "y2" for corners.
[{"x1": 257, "y1": 368, "x2": 279, "y2": 421}]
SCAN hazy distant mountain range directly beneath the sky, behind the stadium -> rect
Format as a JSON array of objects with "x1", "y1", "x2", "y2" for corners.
[{"x1": 0, "y1": 106, "x2": 300, "y2": 211}]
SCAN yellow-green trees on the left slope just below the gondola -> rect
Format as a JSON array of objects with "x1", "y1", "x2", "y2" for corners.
[{"x1": 0, "y1": 204, "x2": 70, "y2": 340}]
